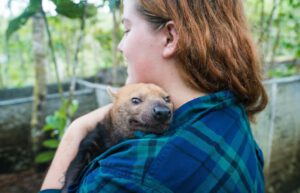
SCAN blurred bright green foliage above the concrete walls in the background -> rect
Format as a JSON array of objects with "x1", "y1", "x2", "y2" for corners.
[{"x1": 0, "y1": 0, "x2": 300, "y2": 88}]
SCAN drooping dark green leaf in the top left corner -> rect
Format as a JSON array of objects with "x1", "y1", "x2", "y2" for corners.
[{"x1": 6, "y1": 0, "x2": 41, "y2": 40}]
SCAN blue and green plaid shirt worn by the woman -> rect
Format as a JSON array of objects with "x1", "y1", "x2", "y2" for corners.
[{"x1": 39, "y1": 91, "x2": 264, "y2": 193}]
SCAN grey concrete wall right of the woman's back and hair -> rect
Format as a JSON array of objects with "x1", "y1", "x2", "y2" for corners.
[{"x1": 253, "y1": 76, "x2": 300, "y2": 192}]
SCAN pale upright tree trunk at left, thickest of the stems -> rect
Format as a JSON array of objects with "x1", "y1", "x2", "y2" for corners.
[{"x1": 31, "y1": 12, "x2": 47, "y2": 161}]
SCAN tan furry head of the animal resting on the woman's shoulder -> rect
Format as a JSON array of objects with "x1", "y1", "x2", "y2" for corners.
[{"x1": 111, "y1": 83, "x2": 173, "y2": 133}]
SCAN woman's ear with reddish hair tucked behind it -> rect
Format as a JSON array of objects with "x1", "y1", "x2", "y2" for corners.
[{"x1": 162, "y1": 21, "x2": 179, "y2": 58}]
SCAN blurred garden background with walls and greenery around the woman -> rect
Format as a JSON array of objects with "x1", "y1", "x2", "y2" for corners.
[{"x1": 0, "y1": 0, "x2": 300, "y2": 193}]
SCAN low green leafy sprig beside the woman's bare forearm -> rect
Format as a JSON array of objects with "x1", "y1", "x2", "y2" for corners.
[{"x1": 35, "y1": 100, "x2": 78, "y2": 163}]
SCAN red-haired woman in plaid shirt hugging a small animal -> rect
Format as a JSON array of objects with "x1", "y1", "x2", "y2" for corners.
[{"x1": 42, "y1": 0, "x2": 267, "y2": 193}]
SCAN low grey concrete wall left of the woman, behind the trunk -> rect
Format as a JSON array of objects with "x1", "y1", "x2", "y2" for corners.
[{"x1": 0, "y1": 83, "x2": 98, "y2": 173}]
